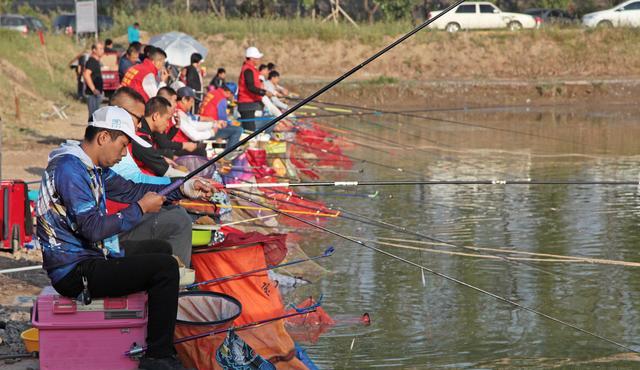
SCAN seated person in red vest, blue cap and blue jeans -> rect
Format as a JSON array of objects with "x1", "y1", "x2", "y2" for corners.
[{"x1": 200, "y1": 85, "x2": 244, "y2": 148}]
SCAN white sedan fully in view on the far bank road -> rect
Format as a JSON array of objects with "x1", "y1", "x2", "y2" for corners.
[{"x1": 428, "y1": 1, "x2": 538, "y2": 32}]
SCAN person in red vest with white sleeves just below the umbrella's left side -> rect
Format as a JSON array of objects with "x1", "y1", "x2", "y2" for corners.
[{"x1": 121, "y1": 47, "x2": 169, "y2": 103}]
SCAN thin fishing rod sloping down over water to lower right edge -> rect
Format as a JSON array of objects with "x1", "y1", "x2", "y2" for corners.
[{"x1": 232, "y1": 192, "x2": 640, "y2": 353}]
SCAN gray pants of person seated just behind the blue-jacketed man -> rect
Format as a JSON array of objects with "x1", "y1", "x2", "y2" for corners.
[{"x1": 119, "y1": 205, "x2": 191, "y2": 266}]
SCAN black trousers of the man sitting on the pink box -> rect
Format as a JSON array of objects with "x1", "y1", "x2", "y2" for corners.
[{"x1": 53, "y1": 240, "x2": 180, "y2": 358}]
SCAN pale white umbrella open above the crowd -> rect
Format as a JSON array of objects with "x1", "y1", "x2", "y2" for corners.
[{"x1": 149, "y1": 32, "x2": 208, "y2": 67}]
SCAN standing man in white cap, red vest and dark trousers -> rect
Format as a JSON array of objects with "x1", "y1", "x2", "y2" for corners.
[{"x1": 238, "y1": 46, "x2": 272, "y2": 131}]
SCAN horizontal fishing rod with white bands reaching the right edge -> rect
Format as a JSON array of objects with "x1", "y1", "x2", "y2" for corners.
[{"x1": 225, "y1": 180, "x2": 640, "y2": 189}]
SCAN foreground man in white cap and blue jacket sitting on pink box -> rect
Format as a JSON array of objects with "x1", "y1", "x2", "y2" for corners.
[{"x1": 36, "y1": 107, "x2": 218, "y2": 370}]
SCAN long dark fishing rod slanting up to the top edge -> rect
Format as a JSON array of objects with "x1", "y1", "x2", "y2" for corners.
[{"x1": 160, "y1": 0, "x2": 465, "y2": 195}]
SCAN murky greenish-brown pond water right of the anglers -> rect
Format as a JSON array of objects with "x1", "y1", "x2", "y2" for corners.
[{"x1": 289, "y1": 103, "x2": 640, "y2": 369}]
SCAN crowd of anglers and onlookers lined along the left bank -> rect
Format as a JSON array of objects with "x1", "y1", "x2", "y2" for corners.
[{"x1": 45, "y1": 34, "x2": 298, "y2": 370}]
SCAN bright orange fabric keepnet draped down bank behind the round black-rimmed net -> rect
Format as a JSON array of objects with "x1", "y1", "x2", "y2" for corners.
[{"x1": 185, "y1": 227, "x2": 306, "y2": 370}]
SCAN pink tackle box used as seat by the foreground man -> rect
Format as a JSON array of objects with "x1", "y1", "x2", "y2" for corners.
[{"x1": 32, "y1": 287, "x2": 147, "y2": 370}]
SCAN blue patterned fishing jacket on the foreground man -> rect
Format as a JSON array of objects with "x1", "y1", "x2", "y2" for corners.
[{"x1": 36, "y1": 141, "x2": 182, "y2": 284}]
